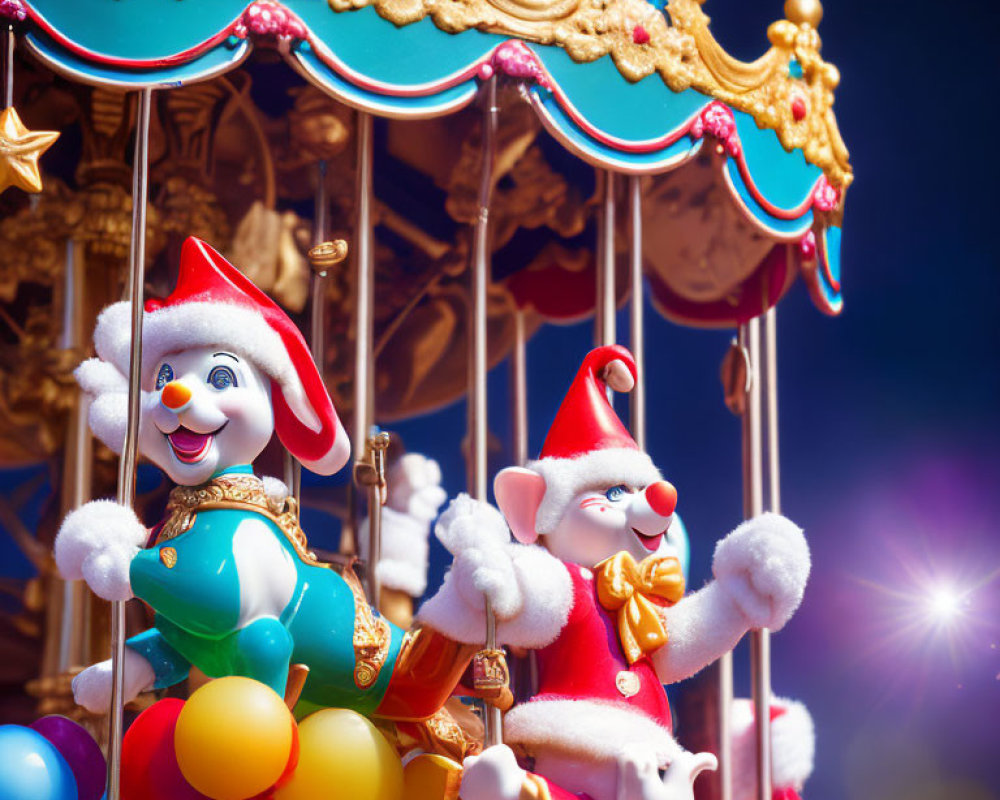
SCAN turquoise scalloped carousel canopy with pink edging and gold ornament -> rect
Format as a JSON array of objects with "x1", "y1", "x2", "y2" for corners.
[{"x1": 15, "y1": 0, "x2": 851, "y2": 325}]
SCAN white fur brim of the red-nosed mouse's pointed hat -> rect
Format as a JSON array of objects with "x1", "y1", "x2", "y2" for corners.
[{"x1": 528, "y1": 447, "x2": 662, "y2": 534}]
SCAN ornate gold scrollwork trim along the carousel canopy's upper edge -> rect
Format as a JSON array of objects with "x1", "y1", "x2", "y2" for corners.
[{"x1": 328, "y1": 0, "x2": 852, "y2": 189}]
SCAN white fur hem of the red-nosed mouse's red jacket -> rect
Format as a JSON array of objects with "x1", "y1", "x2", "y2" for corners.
[{"x1": 503, "y1": 699, "x2": 680, "y2": 768}]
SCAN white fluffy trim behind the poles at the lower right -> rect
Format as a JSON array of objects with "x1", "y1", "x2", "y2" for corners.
[{"x1": 732, "y1": 697, "x2": 816, "y2": 800}]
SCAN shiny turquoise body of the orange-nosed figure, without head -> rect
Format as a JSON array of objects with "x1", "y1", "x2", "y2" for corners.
[{"x1": 127, "y1": 467, "x2": 403, "y2": 714}]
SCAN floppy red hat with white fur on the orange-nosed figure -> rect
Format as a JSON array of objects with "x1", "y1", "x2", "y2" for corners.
[{"x1": 94, "y1": 236, "x2": 350, "y2": 475}]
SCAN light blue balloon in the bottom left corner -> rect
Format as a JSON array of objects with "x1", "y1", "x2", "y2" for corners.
[{"x1": 0, "y1": 725, "x2": 78, "y2": 800}]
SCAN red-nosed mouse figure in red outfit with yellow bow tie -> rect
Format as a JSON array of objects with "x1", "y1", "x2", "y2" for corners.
[{"x1": 418, "y1": 346, "x2": 809, "y2": 800}]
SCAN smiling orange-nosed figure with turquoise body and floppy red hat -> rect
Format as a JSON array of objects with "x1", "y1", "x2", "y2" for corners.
[{"x1": 55, "y1": 238, "x2": 467, "y2": 719}]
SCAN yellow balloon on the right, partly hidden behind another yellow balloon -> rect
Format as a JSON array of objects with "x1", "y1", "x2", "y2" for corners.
[{"x1": 274, "y1": 708, "x2": 403, "y2": 800}]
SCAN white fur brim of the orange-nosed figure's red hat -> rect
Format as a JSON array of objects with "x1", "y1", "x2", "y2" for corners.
[{"x1": 94, "y1": 301, "x2": 320, "y2": 431}]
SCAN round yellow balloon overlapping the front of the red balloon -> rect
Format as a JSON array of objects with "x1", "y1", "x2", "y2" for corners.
[{"x1": 174, "y1": 676, "x2": 295, "y2": 800}]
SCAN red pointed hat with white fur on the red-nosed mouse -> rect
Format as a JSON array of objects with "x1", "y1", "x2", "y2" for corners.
[{"x1": 528, "y1": 345, "x2": 662, "y2": 534}]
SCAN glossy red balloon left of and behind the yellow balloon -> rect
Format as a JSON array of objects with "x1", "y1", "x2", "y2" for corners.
[{"x1": 121, "y1": 698, "x2": 210, "y2": 800}]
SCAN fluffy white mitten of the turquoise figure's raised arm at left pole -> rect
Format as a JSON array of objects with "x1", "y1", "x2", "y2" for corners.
[{"x1": 55, "y1": 500, "x2": 149, "y2": 600}]
